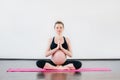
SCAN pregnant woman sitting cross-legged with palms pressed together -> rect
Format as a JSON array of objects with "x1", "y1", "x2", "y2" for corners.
[{"x1": 36, "y1": 21, "x2": 82, "y2": 69}]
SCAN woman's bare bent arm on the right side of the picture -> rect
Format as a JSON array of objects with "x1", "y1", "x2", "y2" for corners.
[{"x1": 60, "y1": 38, "x2": 72, "y2": 57}]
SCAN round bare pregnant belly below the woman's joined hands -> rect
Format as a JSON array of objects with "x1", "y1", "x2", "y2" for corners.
[{"x1": 52, "y1": 50, "x2": 66, "y2": 65}]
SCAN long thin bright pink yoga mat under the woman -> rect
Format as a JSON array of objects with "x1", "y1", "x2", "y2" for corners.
[{"x1": 7, "y1": 68, "x2": 111, "y2": 72}]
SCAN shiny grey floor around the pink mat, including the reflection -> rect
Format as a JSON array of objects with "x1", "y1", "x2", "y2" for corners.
[{"x1": 0, "y1": 60, "x2": 120, "y2": 80}]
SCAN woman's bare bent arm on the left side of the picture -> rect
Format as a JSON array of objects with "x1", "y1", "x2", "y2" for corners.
[{"x1": 45, "y1": 38, "x2": 59, "y2": 57}]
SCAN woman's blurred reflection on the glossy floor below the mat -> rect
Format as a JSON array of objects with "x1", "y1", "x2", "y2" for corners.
[{"x1": 37, "y1": 72, "x2": 81, "y2": 80}]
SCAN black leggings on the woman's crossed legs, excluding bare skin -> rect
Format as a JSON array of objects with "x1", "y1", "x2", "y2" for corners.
[{"x1": 36, "y1": 60, "x2": 82, "y2": 69}]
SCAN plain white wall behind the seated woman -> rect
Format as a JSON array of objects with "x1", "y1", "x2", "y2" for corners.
[{"x1": 0, "y1": 0, "x2": 120, "y2": 59}]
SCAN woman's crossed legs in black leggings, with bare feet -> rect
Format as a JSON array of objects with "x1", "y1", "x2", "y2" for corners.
[{"x1": 36, "y1": 60, "x2": 82, "y2": 69}]
